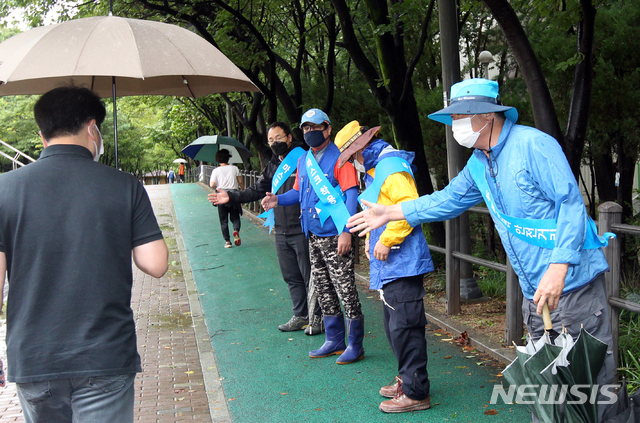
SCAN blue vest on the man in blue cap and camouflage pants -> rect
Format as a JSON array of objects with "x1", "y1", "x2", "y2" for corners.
[{"x1": 298, "y1": 142, "x2": 340, "y2": 237}]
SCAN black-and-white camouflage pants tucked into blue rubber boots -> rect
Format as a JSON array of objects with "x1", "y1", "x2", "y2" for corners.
[{"x1": 309, "y1": 234, "x2": 362, "y2": 319}]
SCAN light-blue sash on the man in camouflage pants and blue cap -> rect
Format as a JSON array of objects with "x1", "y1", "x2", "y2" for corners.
[{"x1": 305, "y1": 150, "x2": 351, "y2": 233}]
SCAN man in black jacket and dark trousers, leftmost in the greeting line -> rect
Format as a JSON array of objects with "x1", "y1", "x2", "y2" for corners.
[{"x1": 209, "y1": 122, "x2": 322, "y2": 335}]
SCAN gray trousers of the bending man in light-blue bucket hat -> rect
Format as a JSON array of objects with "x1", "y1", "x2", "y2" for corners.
[{"x1": 522, "y1": 275, "x2": 616, "y2": 423}]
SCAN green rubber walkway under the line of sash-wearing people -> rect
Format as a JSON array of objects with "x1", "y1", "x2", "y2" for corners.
[{"x1": 171, "y1": 184, "x2": 531, "y2": 423}]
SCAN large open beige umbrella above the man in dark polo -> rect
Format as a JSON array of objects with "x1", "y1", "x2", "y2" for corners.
[{"x1": 0, "y1": 16, "x2": 259, "y2": 167}]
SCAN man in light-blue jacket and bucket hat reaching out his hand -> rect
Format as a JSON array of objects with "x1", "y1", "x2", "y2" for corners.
[{"x1": 349, "y1": 78, "x2": 616, "y2": 416}]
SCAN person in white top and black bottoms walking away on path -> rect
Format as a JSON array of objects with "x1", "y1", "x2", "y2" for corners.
[{"x1": 209, "y1": 149, "x2": 244, "y2": 248}]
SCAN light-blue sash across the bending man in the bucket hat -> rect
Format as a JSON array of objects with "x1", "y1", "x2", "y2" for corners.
[{"x1": 467, "y1": 156, "x2": 616, "y2": 250}]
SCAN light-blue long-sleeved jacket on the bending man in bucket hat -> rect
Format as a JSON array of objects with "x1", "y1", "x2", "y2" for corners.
[{"x1": 402, "y1": 119, "x2": 609, "y2": 300}]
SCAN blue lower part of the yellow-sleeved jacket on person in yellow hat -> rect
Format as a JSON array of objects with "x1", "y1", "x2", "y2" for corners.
[{"x1": 369, "y1": 174, "x2": 433, "y2": 289}]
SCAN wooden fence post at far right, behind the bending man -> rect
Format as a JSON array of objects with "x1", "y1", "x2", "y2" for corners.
[{"x1": 598, "y1": 201, "x2": 622, "y2": 368}]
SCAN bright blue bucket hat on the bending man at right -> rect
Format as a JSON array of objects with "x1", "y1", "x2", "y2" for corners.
[{"x1": 429, "y1": 78, "x2": 518, "y2": 125}]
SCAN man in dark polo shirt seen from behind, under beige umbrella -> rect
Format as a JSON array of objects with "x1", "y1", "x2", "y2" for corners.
[{"x1": 0, "y1": 87, "x2": 168, "y2": 423}]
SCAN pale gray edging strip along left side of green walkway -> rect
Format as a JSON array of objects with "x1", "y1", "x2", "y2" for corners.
[{"x1": 171, "y1": 187, "x2": 233, "y2": 423}]
